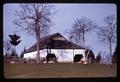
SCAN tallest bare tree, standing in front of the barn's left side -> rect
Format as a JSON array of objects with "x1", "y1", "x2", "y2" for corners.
[{"x1": 14, "y1": 3, "x2": 53, "y2": 63}]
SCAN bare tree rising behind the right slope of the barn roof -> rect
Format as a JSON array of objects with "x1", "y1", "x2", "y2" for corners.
[{"x1": 68, "y1": 17, "x2": 97, "y2": 47}]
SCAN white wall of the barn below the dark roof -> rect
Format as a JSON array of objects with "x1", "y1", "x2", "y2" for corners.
[{"x1": 24, "y1": 49, "x2": 85, "y2": 62}]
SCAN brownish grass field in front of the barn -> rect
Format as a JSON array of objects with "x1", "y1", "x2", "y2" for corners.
[{"x1": 4, "y1": 63, "x2": 117, "y2": 78}]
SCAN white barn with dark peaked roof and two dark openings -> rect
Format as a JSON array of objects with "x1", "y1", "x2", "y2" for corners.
[{"x1": 24, "y1": 33, "x2": 85, "y2": 62}]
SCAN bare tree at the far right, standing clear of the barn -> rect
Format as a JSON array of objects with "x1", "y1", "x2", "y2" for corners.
[{"x1": 97, "y1": 15, "x2": 116, "y2": 63}]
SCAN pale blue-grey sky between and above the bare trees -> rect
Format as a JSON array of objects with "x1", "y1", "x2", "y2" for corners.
[{"x1": 3, "y1": 3, "x2": 117, "y2": 55}]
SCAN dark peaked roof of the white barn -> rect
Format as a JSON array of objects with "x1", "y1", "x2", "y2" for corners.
[{"x1": 26, "y1": 33, "x2": 84, "y2": 53}]
